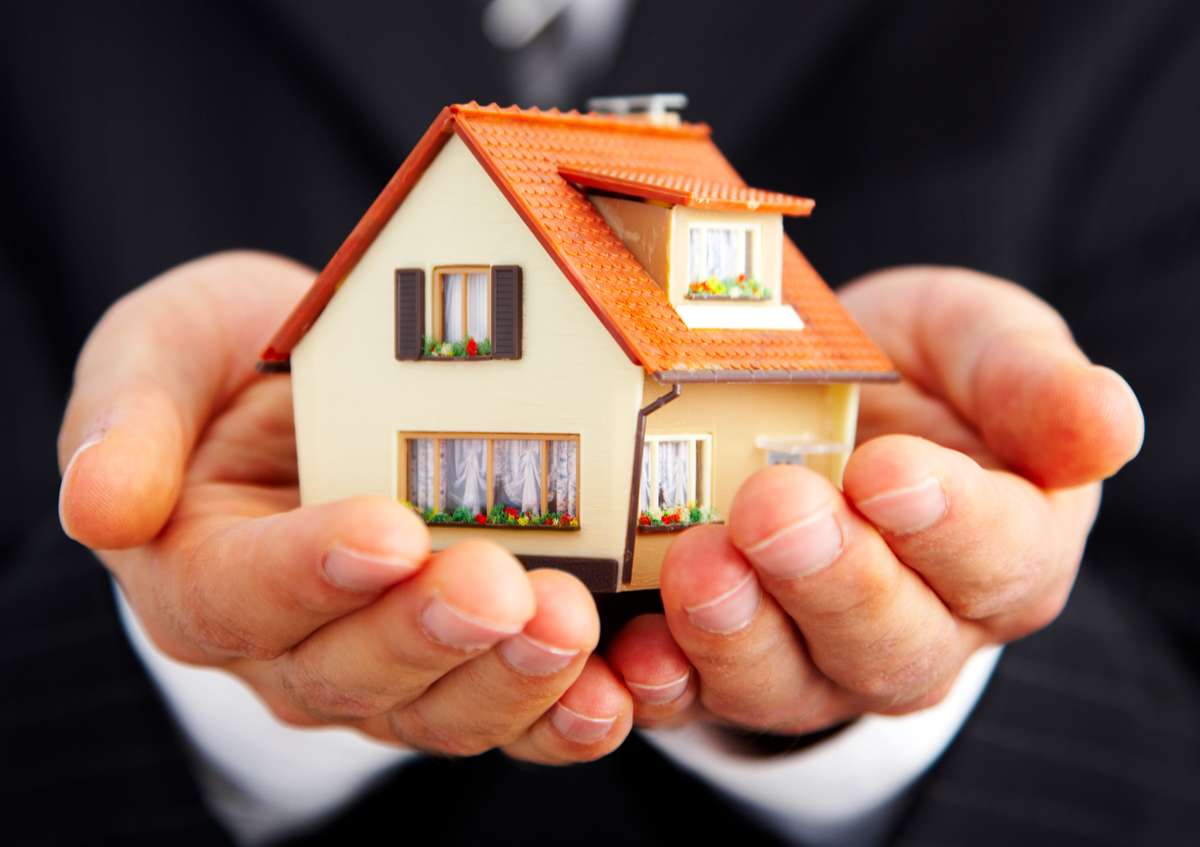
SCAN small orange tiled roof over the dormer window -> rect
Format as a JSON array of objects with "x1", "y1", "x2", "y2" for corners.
[{"x1": 558, "y1": 164, "x2": 812, "y2": 216}]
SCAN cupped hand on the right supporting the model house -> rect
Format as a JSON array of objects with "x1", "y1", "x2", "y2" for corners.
[{"x1": 608, "y1": 268, "x2": 1144, "y2": 733}]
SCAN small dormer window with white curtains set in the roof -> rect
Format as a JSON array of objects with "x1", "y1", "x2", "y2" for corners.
[{"x1": 684, "y1": 224, "x2": 770, "y2": 301}]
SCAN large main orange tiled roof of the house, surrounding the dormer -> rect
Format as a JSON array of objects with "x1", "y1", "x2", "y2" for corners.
[{"x1": 262, "y1": 103, "x2": 895, "y2": 382}]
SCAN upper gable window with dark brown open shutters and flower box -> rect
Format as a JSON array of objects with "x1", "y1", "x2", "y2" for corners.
[{"x1": 396, "y1": 265, "x2": 522, "y2": 361}]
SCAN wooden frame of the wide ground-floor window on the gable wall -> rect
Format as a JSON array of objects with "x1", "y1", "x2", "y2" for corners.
[{"x1": 397, "y1": 431, "x2": 583, "y2": 530}]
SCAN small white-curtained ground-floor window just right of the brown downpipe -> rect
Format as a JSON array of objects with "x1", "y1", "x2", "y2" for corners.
[{"x1": 638, "y1": 435, "x2": 713, "y2": 529}]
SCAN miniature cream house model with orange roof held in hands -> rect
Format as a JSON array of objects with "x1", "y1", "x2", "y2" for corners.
[{"x1": 260, "y1": 103, "x2": 894, "y2": 590}]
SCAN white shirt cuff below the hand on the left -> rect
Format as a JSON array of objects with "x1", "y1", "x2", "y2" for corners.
[{"x1": 114, "y1": 583, "x2": 418, "y2": 845}]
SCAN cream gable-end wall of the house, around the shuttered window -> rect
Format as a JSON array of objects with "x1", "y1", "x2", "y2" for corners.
[{"x1": 292, "y1": 137, "x2": 644, "y2": 560}]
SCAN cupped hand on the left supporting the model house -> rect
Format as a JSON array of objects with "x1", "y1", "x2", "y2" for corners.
[{"x1": 59, "y1": 253, "x2": 632, "y2": 763}]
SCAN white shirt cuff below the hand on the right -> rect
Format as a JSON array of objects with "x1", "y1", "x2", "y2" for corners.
[{"x1": 644, "y1": 647, "x2": 1001, "y2": 845}]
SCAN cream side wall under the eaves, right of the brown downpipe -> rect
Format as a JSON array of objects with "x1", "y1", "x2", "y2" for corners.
[{"x1": 629, "y1": 379, "x2": 858, "y2": 588}]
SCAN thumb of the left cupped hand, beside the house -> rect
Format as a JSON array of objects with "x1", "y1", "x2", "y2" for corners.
[{"x1": 59, "y1": 247, "x2": 312, "y2": 549}]
